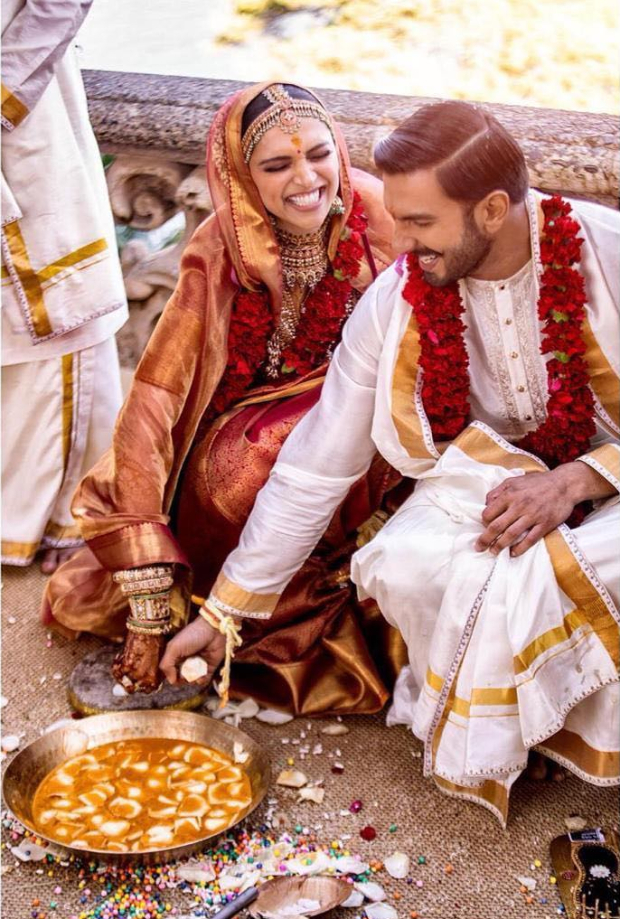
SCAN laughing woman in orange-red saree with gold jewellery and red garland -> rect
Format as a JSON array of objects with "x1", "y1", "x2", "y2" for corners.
[{"x1": 44, "y1": 83, "x2": 404, "y2": 714}]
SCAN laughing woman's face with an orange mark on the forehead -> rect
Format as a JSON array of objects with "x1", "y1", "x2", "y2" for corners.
[{"x1": 250, "y1": 118, "x2": 339, "y2": 234}]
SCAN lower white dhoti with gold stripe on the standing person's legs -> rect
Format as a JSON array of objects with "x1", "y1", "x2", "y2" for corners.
[{"x1": 2, "y1": 338, "x2": 122, "y2": 565}]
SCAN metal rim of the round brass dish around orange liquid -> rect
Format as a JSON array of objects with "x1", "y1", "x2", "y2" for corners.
[{"x1": 2, "y1": 711, "x2": 270, "y2": 863}]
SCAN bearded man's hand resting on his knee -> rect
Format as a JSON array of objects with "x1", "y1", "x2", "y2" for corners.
[{"x1": 476, "y1": 462, "x2": 615, "y2": 558}]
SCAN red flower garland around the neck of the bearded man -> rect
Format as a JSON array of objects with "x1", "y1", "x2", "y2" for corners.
[{"x1": 403, "y1": 196, "x2": 596, "y2": 468}]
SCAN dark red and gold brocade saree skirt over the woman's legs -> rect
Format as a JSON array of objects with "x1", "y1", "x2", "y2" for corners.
[{"x1": 175, "y1": 379, "x2": 406, "y2": 715}]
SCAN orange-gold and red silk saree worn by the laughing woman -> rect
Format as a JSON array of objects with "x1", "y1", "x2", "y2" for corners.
[{"x1": 44, "y1": 83, "x2": 404, "y2": 714}]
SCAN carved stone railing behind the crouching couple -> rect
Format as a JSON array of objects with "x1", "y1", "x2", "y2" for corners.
[{"x1": 84, "y1": 71, "x2": 619, "y2": 367}]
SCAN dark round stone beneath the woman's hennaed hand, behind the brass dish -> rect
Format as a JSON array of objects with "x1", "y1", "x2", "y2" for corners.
[{"x1": 68, "y1": 646, "x2": 209, "y2": 715}]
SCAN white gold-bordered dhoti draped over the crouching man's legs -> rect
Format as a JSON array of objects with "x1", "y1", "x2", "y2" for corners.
[{"x1": 352, "y1": 447, "x2": 620, "y2": 820}]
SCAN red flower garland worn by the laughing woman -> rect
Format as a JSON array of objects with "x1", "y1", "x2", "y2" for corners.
[{"x1": 210, "y1": 192, "x2": 368, "y2": 415}]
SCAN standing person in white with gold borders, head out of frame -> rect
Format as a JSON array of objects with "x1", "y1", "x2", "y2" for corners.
[{"x1": 2, "y1": 0, "x2": 127, "y2": 573}]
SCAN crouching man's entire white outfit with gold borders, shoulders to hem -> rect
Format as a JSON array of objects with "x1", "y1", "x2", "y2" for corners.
[{"x1": 210, "y1": 190, "x2": 620, "y2": 820}]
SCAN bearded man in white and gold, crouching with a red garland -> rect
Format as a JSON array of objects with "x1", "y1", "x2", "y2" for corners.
[{"x1": 161, "y1": 103, "x2": 620, "y2": 822}]
